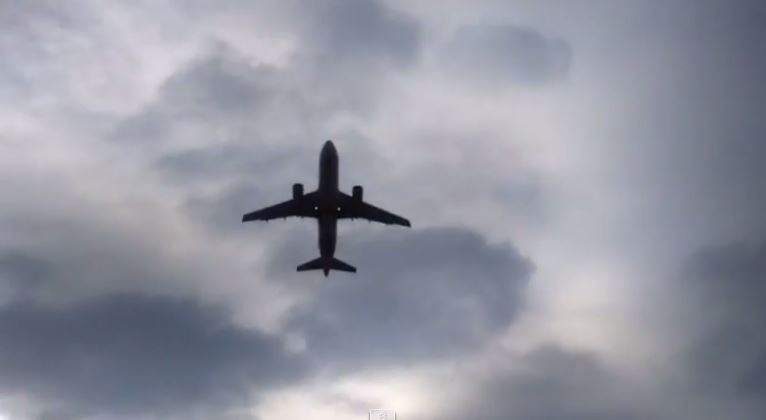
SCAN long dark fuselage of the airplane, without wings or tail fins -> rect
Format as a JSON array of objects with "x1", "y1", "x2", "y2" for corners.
[{"x1": 315, "y1": 141, "x2": 340, "y2": 266}]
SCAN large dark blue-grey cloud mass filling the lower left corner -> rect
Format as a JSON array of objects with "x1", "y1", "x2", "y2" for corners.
[{"x1": 0, "y1": 190, "x2": 309, "y2": 419}]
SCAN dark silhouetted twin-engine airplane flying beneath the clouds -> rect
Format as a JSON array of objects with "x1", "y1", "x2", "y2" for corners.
[{"x1": 242, "y1": 140, "x2": 411, "y2": 277}]
